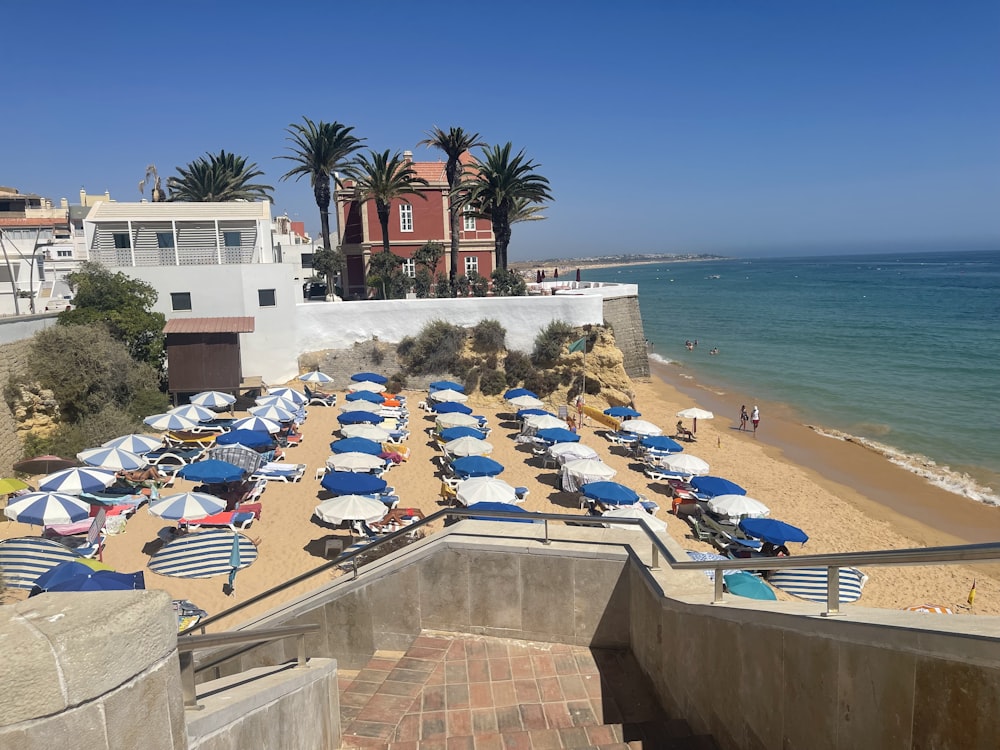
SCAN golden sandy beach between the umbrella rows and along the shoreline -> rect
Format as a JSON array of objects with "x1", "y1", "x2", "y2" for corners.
[{"x1": 0, "y1": 363, "x2": 1000, "y2": 629}]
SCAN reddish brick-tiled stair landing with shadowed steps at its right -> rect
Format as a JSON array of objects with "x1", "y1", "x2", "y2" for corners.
[{"x1": 340, "y1": 632, "x2": 716, "y2": 750}]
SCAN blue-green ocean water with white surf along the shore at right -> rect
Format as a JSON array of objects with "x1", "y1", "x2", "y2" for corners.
[{"x1": 582, "y1": 251, "x2": 1000, "y2": 504}]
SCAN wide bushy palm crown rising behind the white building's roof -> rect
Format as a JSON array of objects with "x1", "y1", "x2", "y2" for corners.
[{"x1": 167, "y1": 149, "x2": 274, "y2": 202}]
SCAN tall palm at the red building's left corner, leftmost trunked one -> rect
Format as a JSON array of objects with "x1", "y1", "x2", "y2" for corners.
[{"x1": 275, "y1": 117, "x2": 364, "y2": 296}]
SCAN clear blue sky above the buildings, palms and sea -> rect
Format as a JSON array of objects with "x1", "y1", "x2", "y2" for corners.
[{"x1": 0, "y1": 0, "x2": 1000, "y2": 260}]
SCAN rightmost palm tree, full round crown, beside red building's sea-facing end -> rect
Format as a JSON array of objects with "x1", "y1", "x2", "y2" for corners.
[{"x1": 461, "y1": 141, "x2": 552, "y2": 271}]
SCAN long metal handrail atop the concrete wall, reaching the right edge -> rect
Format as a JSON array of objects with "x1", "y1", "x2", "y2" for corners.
[{"x1": 192, "y1": 508, "x2": 1000, "y2": 632}]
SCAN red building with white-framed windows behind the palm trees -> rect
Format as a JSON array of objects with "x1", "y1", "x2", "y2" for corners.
[{"x1": 334, "y1": 151, "x2": 496, "y2": 299}]
